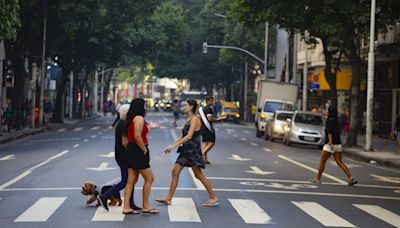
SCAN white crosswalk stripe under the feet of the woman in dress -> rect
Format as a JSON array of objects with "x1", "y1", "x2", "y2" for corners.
[{"x1": 168, "y1": 198, "x2": 201, "y2": 222}]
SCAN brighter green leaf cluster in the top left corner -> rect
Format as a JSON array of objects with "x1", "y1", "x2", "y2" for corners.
[{"x1": 0, "y1": 0, "x2": 21, "y2": 40}]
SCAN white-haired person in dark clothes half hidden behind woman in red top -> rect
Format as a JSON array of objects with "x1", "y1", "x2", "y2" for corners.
[{"x1": 97, "y1": 104, "x2": 141, "y2": 213}]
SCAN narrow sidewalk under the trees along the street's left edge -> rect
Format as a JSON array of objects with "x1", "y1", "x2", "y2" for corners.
[{"x1": 0, "y1": 116, "x2": 100, "y2": 144}]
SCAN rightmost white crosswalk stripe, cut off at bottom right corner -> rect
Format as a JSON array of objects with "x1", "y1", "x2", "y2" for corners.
[{"x1": 353, "y1": 204, "x2": 400, "y2": 227}]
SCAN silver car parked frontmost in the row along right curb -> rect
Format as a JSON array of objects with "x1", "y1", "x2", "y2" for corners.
[{"x1": 283, "y1": 111, "x2": 325, "y2": 148}]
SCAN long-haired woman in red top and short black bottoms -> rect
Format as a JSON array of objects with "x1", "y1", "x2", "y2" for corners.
[{"x1": 122, "y1": 98, "x2": 159, "y2": 214}]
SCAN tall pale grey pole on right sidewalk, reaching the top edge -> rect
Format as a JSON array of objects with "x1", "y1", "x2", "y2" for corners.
[{"x1": 365, "y1": 0, "x2": 376, "y2": 151}]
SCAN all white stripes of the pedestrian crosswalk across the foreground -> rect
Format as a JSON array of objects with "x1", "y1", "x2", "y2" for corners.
[{"x1": 6, "y1": 197, "x2": 400, "y2": 227}]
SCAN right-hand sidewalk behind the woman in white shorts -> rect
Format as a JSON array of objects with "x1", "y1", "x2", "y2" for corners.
[{"x1": 342, "y1": 135, "x2": 400, "y2": 169}]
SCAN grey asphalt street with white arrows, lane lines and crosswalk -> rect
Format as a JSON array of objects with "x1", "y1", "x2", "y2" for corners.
[{"x1": 0, "y1": 112, "x2": 400, "y2": 228}]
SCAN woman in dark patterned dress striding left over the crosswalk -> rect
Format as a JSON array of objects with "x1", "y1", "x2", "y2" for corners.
[{"x1": 156, "y1": 100, "x2": 218, "y2": 207}]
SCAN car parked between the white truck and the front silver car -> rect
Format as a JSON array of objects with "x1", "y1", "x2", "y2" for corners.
[{"x1": 265, "y1": 110, "x2": 294, "y2": 141}]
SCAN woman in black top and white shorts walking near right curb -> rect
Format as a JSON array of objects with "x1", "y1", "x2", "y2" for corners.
[{"x1": 311, "y1": 107, "x2": 357, "y2": 186}]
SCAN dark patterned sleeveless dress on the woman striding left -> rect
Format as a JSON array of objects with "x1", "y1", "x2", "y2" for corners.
[{"x1": 175, "y1": 123, "x2": 205, "y2": 169}]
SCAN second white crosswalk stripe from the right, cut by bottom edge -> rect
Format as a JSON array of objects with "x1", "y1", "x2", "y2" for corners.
[{"x1": 292, "y1": 201, "x2": 355, "y2": 227}]
